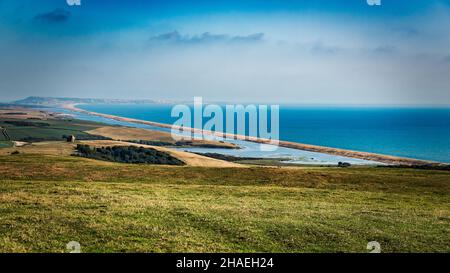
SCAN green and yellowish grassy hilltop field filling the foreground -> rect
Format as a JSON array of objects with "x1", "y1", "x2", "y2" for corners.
[{"x1": 0, "y1": 154, "x2": 450, "y2": 252}]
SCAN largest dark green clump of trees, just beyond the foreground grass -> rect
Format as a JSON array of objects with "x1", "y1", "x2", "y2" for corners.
[{"x1": 77, "y1": 144, "x2": 184, "y2": 165}]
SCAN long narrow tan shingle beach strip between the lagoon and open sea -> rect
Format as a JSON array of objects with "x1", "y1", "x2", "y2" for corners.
[{"x1": 60, "y1": 104, "x2": 444, "y2": 166}]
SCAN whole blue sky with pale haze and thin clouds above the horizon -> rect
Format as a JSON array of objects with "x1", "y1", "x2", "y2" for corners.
[{"x1": 0, "y1": 0, "x2": 450, "y2": 105}]
